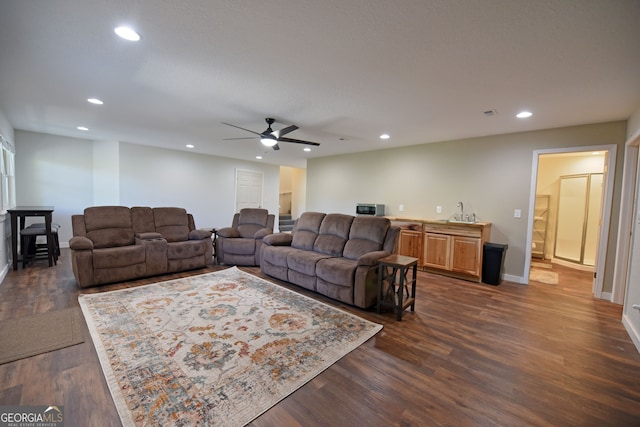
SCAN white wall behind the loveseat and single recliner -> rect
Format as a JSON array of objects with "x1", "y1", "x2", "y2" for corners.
[{"x1": 15, "y1": 131, "x2": 279, "y2": 246}]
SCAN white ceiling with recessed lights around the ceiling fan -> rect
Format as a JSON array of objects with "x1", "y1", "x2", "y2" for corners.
[{"x1": 0, "y1": 0, "x2": 640, "y2": 167}]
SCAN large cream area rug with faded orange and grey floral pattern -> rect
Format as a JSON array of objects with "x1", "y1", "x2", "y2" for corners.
[{"x1": 79, "y1": 267, "x2": 382, "y2": 426}]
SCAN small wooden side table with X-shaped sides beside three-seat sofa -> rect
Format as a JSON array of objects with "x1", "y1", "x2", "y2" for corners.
[{"x1": 377, "y1": 255, "x2": 418, "y2": 321}]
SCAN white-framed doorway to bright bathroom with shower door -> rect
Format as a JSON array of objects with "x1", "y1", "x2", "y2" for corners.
[{"x1": 526, "y1": 146, "x2": 615, "y2": 298}]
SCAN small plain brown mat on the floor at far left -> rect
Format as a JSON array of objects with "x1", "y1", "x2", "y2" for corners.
[{"x1": 0, "y1": 307, "x2": 84, "y2": 364}]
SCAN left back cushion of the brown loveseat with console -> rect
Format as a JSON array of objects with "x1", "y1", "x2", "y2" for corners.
[{"x1": 84, "y1": 206, "x2": 135, "y2": 249}]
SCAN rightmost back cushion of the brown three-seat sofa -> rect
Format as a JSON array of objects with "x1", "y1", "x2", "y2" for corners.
[{"x1": 342, "y1": 216, "x2": 391, "y2": 259}]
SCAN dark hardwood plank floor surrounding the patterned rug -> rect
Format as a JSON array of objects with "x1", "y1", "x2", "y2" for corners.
[{"x1": 0, "y1": 249, "x2": 640, "y2": 427}]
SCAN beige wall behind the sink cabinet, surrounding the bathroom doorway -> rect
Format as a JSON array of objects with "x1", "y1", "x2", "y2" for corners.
[{"x1": 307, "y1": 121, "x2": 626, "y2": 292}]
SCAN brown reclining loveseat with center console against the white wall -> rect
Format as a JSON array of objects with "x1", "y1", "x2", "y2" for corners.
[{"x1": 69, "y1": 206, "x2": 213, "y2": 288}]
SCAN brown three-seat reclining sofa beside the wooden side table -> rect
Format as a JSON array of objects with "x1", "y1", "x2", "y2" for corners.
[{"x1": 260, "y1": 212, "x2": 400, "y2": 308}]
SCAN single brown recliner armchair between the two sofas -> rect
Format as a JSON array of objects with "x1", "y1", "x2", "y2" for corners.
[{"x1": 216, "y1": 208, "x2": 275, "y2": 266}]
